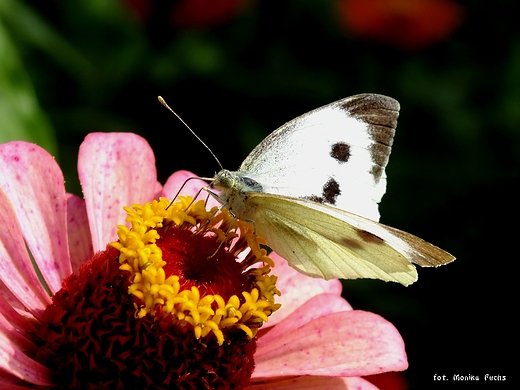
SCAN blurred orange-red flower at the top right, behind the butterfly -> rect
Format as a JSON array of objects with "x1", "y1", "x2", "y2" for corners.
[{"x1": 337, "y1": 0, "x2": 463, "y2": 50}]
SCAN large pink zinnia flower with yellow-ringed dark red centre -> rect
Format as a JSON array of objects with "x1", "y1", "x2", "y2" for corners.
[{"x1": 0, "y1": 133, "x2": 407, "y2": 389}]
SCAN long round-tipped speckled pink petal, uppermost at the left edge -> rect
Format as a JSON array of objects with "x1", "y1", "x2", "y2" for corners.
[{"x1": 0, "y1": 141, "x2": 71, "y2": 292}]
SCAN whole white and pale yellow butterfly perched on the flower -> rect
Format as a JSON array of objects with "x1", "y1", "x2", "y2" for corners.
[{"x1": 159, "y1": 94, "x2": 455, "y2": 285}]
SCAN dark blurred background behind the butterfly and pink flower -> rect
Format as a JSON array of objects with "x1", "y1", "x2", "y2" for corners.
[{"x1": 0, "y1": 0, "x2": 520, "y2": 389}]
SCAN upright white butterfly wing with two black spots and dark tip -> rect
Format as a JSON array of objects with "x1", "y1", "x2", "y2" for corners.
[{"x1": 239, "y1": 94, "x2": 399, "y2": 220}]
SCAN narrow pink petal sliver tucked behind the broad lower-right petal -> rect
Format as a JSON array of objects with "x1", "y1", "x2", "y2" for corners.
[{"x1": 257, "y1": 294, "x2": 352, "y2": 344}]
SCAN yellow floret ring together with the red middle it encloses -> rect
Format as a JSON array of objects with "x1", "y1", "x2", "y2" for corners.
[{"x1": 111, "y1": 197, "x2": 280, "y2": 345}]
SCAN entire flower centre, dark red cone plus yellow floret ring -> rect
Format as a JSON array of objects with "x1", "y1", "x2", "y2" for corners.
[{"x1": 35, "y1": 197, "x2": 280, "y2": 389}]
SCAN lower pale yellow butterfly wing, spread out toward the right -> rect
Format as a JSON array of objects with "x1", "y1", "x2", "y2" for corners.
[{"x1": 247, "y1": 192, "x2": 454, "y2": 285}]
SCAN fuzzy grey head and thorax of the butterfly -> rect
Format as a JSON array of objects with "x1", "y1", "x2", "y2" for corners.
[{"x1": 211, "y1": 169, "x2": 263, "y2": 219}]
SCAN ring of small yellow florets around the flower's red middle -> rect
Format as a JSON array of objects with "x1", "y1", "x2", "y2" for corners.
[{"x1": 111, "y1": 196, "x2": 280, "y2": 345}]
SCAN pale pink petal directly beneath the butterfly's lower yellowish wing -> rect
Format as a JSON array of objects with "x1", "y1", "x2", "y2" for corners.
[{"x1": 266, "y1": 252, "x2": 342, "y2": 326}]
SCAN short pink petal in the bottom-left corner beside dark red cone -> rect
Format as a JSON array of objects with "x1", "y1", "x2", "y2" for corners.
[{"x1": 0, "y1": 332, "x2": 52, "y2": 386}]
